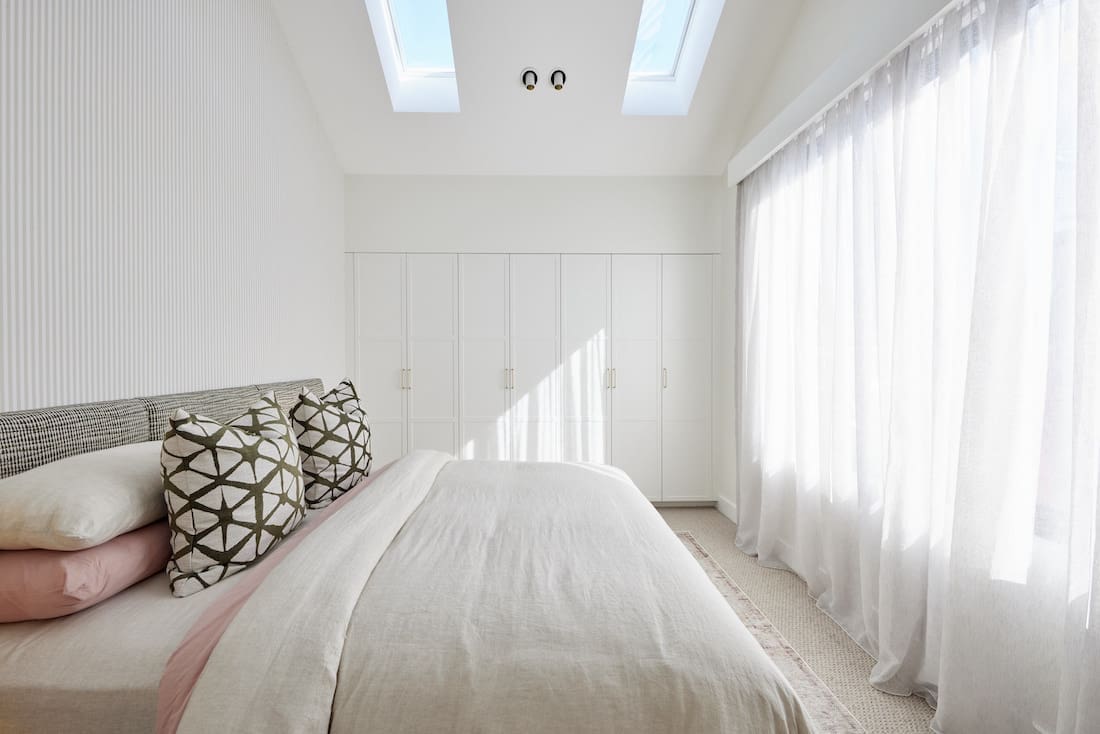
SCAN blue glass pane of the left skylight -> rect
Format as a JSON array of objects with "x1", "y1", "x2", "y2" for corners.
[{"x1": 387, "y1": 0, "x2": 454, "y2": 75}]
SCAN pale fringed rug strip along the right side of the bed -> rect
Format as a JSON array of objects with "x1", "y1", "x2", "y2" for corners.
[{"x1": 677, "y1": 533, "x2": 866, "y2": 734}]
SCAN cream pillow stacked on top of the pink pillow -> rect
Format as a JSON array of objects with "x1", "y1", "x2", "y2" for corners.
[{"x1": 0, "y1": 441, "x2": 168, "y2": 550}]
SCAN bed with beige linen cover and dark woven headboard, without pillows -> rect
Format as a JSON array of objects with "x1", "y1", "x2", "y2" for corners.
[{"x1": 0, "y1": 383, "x2": 813, "y2": 734}]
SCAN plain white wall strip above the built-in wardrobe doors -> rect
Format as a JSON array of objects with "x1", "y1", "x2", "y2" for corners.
[{"x1": 347, "y1": 176, "x2": 726, "y2": 253}]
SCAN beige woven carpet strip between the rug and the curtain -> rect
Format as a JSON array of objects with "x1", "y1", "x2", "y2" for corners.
[{"x1": 660, "y1": 507, "x2": 934, "y2": 734}]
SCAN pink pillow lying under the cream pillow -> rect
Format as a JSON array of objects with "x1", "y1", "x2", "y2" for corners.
[{"x1": 0, "y1": 523, "x2": 172, "y2": 622}]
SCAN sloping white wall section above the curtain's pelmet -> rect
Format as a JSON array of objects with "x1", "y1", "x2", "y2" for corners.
[{"x1": 727, "y1": 0, "x2": 950, "y2": 184}]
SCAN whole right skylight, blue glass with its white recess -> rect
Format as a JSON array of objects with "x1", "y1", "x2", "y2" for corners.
[{"x1": 623, "y1": 0, "x2": 726, "y2": 114}]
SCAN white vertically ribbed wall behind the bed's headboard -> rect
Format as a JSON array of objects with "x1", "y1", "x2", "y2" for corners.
[{"x1": 0, "y1": 0, "x2": 344, "y2": 410}]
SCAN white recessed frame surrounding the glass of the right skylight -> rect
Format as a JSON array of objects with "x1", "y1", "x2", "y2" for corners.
[{"x1": 623, "y1": 0, "x2": 726, "y2": 117}]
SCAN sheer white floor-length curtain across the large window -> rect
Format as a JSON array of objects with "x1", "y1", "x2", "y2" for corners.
[{"x1": 737, "y1": 0, "x2": 1100, "y2": 734}]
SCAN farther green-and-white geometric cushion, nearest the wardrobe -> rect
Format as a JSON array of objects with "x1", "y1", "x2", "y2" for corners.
[{"x1": 290, "y1": 380, "x2": 371, "y2": 510}]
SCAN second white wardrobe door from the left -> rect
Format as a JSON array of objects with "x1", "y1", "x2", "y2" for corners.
[{"x1": 406, "y1": 254, "x2": 459, "y2": 453}]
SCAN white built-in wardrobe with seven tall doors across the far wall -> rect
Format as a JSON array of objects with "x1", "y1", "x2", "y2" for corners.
[{"x1": 348, "y1": 253, "x2": 717, "y2": 502}]
